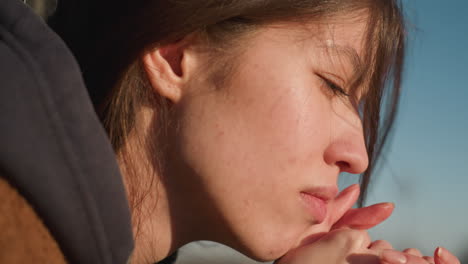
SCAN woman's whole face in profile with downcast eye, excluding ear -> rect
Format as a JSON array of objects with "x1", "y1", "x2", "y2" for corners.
[{"x1": 166, "y1": 16, "x2": 368, "y2": 260}]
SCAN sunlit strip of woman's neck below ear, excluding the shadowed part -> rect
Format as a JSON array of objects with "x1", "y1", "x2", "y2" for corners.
[{"x1": 118, "y1": 125, "x2": 181, "y2": 264}]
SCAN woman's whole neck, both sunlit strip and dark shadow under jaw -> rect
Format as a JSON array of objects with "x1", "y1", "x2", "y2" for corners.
[{"x1": 117, "y1": 108, "x2": 216, "y2": 264}]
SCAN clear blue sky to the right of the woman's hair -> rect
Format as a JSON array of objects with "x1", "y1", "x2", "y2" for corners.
[{"x1": 336, "y1": 0, "x2": 468, "y2": 256}]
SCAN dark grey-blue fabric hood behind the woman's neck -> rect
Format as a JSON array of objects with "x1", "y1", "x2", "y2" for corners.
[{"x1": 0, "y1": 0, "x2": 133, "y2": 264}]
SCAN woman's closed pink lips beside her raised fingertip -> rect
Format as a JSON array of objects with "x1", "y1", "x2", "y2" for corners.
[{"x1": 300, "y1": 186, "x2": 338, "y2": 224}]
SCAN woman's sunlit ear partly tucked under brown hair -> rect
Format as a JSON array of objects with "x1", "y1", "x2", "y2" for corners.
[{"x1": 143, "y1": 39, "x2": 194, "y2": 103}]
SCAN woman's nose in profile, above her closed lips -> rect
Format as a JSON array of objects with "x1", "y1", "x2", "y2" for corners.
[{"x1": 324, "y1": 124, "x2": 369, "y2": 174}]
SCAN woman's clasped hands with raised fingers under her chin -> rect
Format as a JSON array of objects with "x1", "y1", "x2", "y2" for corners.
[{"x1": 276, "y1": 186, "x2": 460, "y2": 264}]
